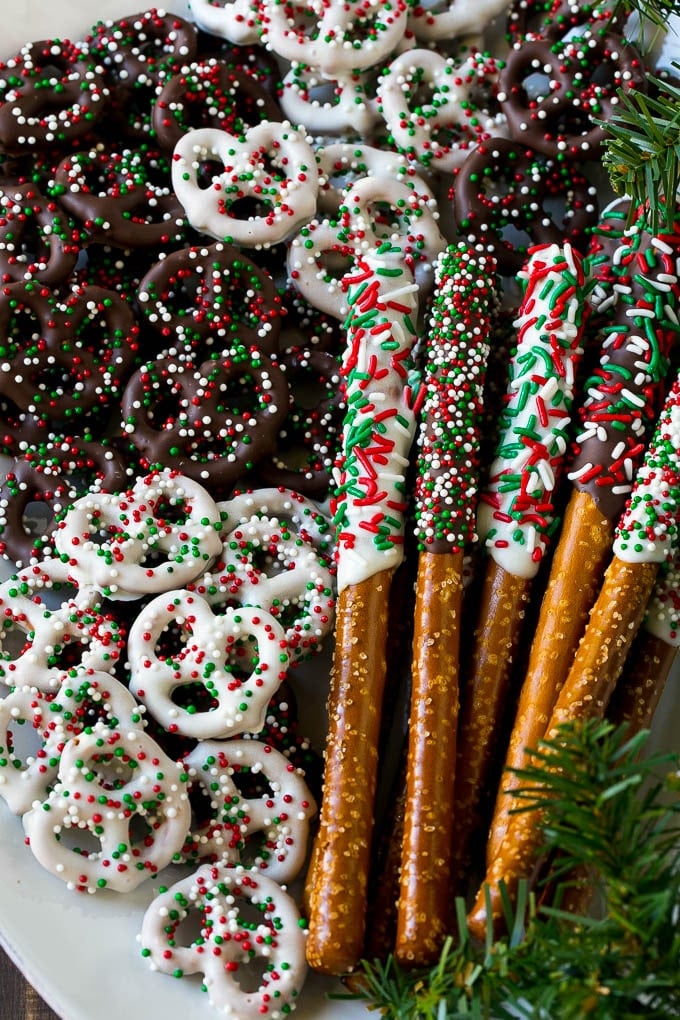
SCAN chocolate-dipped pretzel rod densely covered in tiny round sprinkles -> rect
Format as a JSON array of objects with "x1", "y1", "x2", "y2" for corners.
[{"x1": 396, "y1": 242, "x2": 498, "y2": 966}]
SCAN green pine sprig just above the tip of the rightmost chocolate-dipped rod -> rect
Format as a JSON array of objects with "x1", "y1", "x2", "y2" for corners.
[{"x1": 604, "y1": 77, "x2": 680, "y2": 234}]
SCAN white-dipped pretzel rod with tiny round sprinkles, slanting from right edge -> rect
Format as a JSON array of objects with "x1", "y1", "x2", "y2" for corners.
[{"x1": 468, "y1": 375, "x2": 680, "y2": 937}]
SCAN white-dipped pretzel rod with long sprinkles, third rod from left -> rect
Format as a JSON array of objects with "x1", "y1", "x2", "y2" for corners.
[{"x1": 448, "y1": 245, "x2": 584, "y2": 885}]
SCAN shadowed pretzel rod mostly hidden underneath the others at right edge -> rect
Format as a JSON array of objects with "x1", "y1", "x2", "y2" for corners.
[{"x1": 608, "y1": 556, "x2": 680, "y2": 730}]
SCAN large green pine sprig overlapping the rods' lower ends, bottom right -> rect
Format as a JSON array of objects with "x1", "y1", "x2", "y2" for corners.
[{"x1": 354, "y1": 720, "x2": 680, "y2": 1020}]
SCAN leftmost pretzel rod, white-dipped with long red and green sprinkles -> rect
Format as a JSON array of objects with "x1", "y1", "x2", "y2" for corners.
[{"x1": 306, "y1": 243, "x2": 417, "y2": 974}]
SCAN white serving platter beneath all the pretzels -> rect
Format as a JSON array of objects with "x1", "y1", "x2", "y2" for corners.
[{"x1": 0, "y1": 0, "x2": 680, "y2": 1020}]
